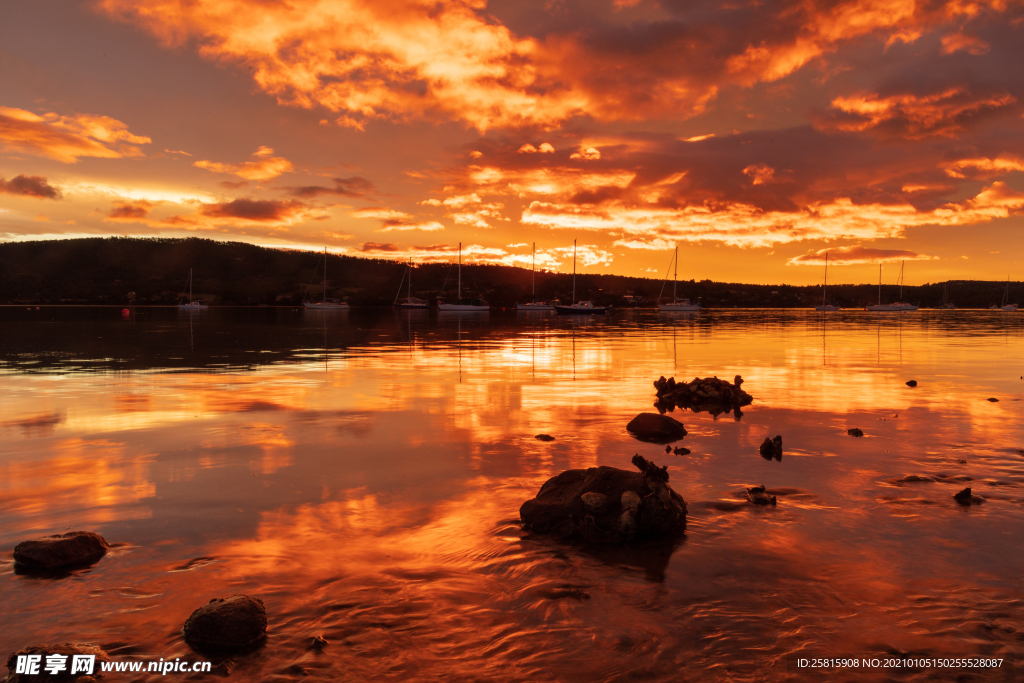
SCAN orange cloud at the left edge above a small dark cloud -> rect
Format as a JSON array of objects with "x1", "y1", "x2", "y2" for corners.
[{"x1": 0, "y1": 106, "x2": 152, "y2": 164}]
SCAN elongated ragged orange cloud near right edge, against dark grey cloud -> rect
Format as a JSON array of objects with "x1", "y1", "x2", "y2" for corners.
[{"x1": 824, "y1": 87, "x2": 1017, "y2": 139}]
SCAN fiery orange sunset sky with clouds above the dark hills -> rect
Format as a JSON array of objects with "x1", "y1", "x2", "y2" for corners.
[{"x1": 0, "y1": 0, "x2": 1024, "y2": 285}]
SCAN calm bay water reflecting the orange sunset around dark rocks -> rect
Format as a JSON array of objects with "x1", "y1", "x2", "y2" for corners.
[{"x1": 0, "y1": 308, "x2": 1024, "y2": 681}]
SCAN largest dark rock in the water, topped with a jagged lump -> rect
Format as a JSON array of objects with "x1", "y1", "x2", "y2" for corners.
[{"x1": 519, "y1": 456, "x2": 686, "y2": 543}]
